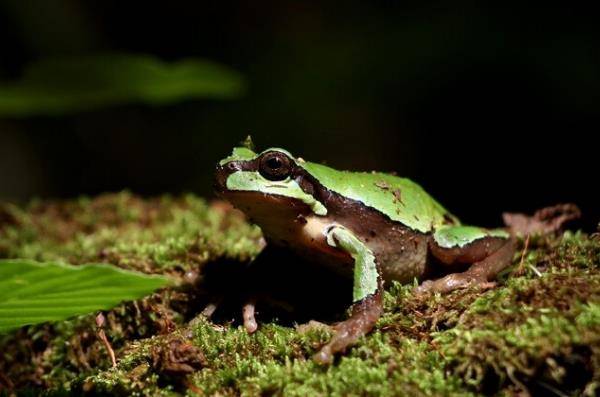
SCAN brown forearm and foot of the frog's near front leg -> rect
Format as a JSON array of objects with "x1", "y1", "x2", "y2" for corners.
[{"x1": 313, "y1": 290, "x2": 383, "y2": 365}]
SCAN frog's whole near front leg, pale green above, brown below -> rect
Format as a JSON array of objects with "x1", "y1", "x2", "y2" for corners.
[{"x1": 314, "y1": 226, "x2": 383, "y2": 364}]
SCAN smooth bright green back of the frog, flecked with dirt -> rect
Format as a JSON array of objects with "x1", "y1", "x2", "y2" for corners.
[{"x1": 299, "y1": 162, "x2": 459, "y2": 233}]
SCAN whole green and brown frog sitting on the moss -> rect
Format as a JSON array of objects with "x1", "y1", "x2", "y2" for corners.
[{"x1": 216, "y1": 147, "x2": 514, "y2": 363}]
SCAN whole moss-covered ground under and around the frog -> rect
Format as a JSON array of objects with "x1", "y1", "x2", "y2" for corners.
[{"x1": 0, "y1": 193, "x2": 600, "y2": 396}]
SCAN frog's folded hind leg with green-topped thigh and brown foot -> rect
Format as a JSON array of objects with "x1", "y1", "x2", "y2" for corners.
[{"x1": 416, "y1": 226, "x2": 515, "y2": 293}]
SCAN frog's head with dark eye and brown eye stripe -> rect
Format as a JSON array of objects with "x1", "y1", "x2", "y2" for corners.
[{"x1": 215, "y1": 147, "x2": 327, "y2": 234}]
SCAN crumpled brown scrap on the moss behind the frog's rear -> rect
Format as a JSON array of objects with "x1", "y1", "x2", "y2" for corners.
[{"x1": 502, "y1": 204, "x2": 581, "y2": 236}]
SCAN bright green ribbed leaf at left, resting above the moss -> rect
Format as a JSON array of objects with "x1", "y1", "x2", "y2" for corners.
[{"x1": 0, "y1": 259, "x2": 169, "y2": 333}]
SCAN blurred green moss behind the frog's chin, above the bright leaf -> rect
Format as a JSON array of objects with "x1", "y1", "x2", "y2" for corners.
[{"x1": 0, "y1": 192, "x2": 261, "y2": 272}]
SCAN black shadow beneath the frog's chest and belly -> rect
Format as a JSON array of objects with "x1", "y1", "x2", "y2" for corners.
[{"x1": 194, "y1": 247, "x2": 352, "y2": 327}]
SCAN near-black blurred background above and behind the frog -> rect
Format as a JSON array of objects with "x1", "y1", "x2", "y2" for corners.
[{"x1": 0, "y1": 0, "x2": 600, "y2": 230}]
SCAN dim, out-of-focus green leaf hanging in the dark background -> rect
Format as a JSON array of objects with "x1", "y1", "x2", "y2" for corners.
[{"x1": 0, "y1": 54, "x2": 243, "y2": 117}]
